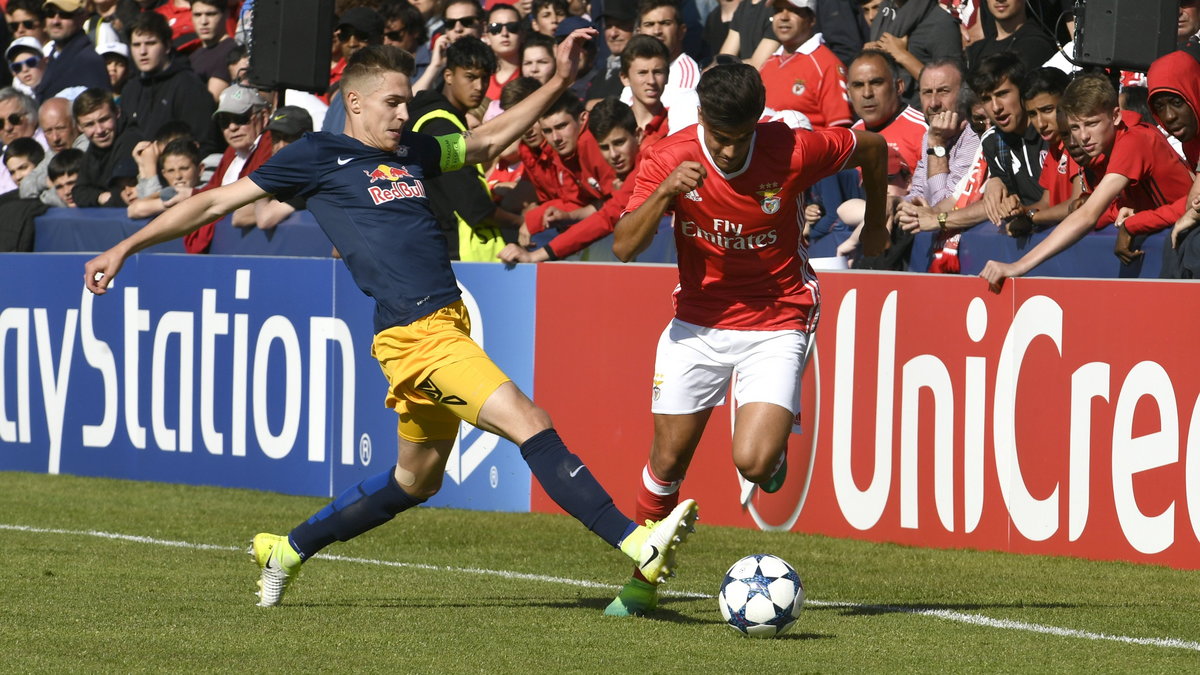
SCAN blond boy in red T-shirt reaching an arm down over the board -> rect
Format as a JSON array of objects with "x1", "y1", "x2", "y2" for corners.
[{"x1": 979, "y1": 74, "x2": 1192, "y2": 293}]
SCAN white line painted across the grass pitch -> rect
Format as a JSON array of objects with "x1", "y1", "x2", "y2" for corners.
[{"x1": 0, "y1": 524, "x2": 1200, "y2": 651}]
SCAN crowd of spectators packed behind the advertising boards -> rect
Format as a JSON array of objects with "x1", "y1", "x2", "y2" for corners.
[{"x1": 0, "y1": 0, "x2": 1200, "y2": 277}]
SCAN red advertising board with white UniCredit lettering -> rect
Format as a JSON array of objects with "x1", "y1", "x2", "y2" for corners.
[{"x1": 533, "y1": 265, "x2": 1200, "y2": 568}]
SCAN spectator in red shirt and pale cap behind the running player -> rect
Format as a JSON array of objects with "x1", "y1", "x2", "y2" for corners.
[{"x1": 758, "y1": 0, "x2": 851, "y2": 127}]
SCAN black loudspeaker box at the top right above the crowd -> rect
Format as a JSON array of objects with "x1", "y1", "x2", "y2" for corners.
[{"x1": 1075, "y1": 0, "x2": 1180, "y2": 72}]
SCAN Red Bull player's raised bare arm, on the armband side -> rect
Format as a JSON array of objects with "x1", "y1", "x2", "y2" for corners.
[{"x1": 467, "y1": 28, "x2": 596, "y2": 165}]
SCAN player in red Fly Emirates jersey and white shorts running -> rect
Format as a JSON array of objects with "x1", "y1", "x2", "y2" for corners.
[{"x1": 605, "y1": 64, "x2": 888, "y2": 616}]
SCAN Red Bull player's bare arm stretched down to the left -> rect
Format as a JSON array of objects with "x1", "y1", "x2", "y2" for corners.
[{"x1": 83, "y1": 178, "x2": 268, "y2": 295}]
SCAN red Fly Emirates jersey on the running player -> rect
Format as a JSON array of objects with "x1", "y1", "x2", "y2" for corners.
[{"x1": 625, "y1": 123, "x2": 856, "y2": 330}]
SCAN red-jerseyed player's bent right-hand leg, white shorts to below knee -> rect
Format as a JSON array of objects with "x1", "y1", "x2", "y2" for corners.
[{"x1": 733, "y1": 330, "x2": 810, "y2": 492}]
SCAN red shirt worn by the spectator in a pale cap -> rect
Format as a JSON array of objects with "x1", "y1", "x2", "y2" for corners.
[{"x1": 758, "y1": 37, "x2": 854, "y2": 127}]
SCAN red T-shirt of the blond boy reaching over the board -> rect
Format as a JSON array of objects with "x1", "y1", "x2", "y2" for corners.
[{"x1": 1088, "y1": 113, "x2": 1193, "y2": 234}]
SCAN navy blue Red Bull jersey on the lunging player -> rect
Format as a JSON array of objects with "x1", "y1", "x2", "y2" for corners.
[{"x1": 250, "y1": 131, "x2": 466, "y2": 333}]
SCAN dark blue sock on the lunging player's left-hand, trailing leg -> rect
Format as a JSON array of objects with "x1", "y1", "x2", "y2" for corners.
[{"x1": 288, "y1": 468, "x2": 425, "y2": 560}]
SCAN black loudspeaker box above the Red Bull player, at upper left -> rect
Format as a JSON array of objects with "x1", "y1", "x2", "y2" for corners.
[{"x1": 250, "y1": 0, "x2": 334, "y2": 94}]
